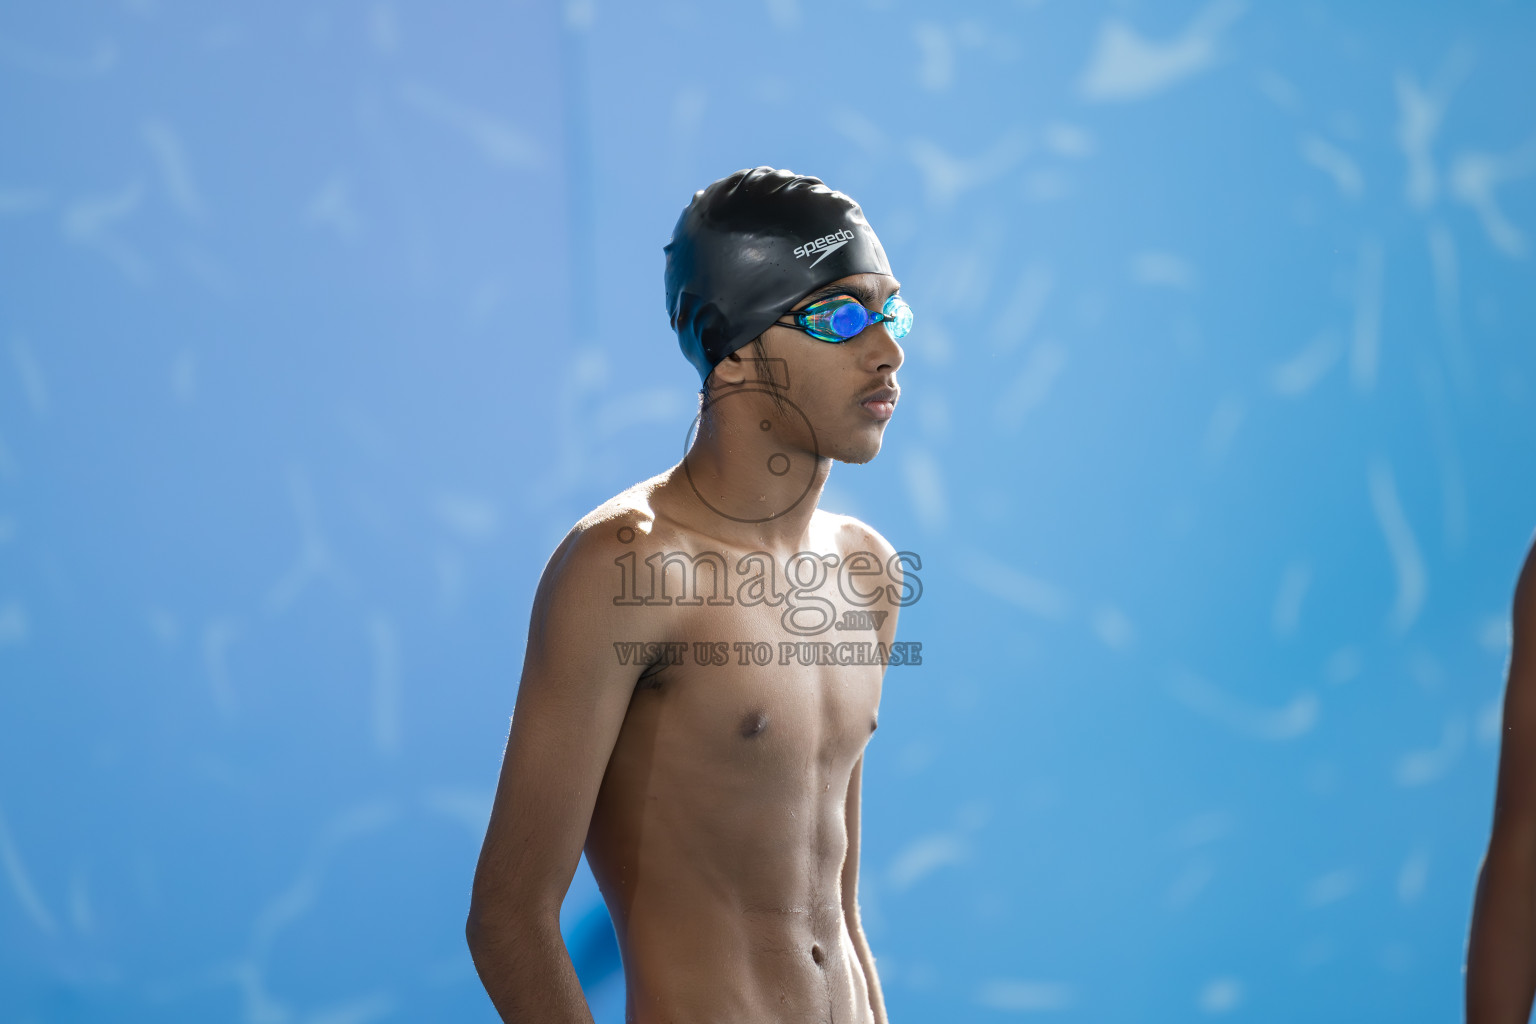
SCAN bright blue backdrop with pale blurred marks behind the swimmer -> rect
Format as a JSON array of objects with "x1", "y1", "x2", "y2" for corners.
[{"x1": 0, "y1": 0, "x2": 1536, "y2": 1024}]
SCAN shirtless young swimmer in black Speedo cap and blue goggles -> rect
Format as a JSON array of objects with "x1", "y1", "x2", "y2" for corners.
[{"x1": 467, "y1": 167, "x2": 920, "y2": 1024}]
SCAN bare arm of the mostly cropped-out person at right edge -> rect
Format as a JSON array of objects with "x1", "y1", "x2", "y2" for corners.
[{"x1": 1467, "y1": 548, "x2": 1536, "y2": 1024}]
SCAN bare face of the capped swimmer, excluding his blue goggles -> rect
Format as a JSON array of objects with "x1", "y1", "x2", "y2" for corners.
[{"x1": 727, "y1": 273, "x2": 903, "y2": 464}]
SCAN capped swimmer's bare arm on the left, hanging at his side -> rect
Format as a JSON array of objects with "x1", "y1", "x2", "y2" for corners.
[{"x1": 465, "y1": 531, "x2": 637, "y2": 1024}]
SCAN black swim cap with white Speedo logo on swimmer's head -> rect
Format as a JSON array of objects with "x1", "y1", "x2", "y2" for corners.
[{"x1": 667, "y1": 167, "x2": 891, "y2": 381}]
